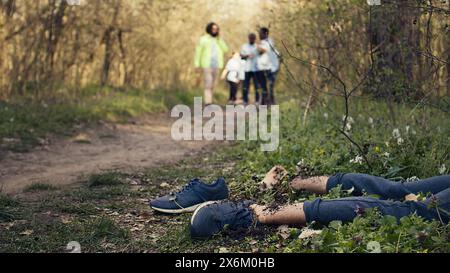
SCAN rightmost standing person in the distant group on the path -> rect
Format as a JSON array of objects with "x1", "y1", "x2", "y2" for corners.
[{"x1": 256, "y1": 27, "x2": 280, "y2": 105}]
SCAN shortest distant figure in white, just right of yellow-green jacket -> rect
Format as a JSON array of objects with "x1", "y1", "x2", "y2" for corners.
[{"x1": 222, "y1": 52, "x2": 246, "y2": 104}]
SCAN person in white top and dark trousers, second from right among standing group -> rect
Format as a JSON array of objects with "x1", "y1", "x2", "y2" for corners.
[{"x1": 241, "y1": 33, "x2": 261, "y2": 105}]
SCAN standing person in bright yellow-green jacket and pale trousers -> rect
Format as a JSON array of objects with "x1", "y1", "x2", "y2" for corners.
[{"x1": 195, "y1": 23, "x2": 228, "y2": 105}]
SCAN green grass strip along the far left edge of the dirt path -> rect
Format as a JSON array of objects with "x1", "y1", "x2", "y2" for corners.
[{"x1": 0, "y1": 86, "x2": 204, "y2": 152}]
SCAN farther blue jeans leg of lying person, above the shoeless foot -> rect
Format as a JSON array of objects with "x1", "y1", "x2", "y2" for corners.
[{"x1": 327, "y1": 174, "x2": 450, "y2": 200}]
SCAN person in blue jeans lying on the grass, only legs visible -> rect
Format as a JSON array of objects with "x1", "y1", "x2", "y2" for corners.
[{"x1": 152, "y1": 174, "x2": 450, "y2": 239}]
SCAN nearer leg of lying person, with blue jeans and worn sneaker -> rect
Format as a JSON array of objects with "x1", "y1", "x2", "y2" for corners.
[{"x1": 191, "y1": 189, "x2": 450, "y2": 239}]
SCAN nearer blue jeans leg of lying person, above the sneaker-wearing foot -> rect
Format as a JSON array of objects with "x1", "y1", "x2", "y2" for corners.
[{"x1": 304, "y1": 189, "x2": 450, "y2": 224}]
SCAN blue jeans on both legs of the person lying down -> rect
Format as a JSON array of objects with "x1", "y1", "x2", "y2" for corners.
[{"x1": 304, "y1": 174, "x2": 450, "y2": 224}]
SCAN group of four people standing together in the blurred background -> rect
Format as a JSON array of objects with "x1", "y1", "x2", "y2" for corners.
[{"x1": 195, "y1": 23, "x2": 280, "y2": 105}]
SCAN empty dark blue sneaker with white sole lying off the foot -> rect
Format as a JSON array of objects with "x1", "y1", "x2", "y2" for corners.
[{"x1": 150, "y1": 178, "x2": 229, "y2": 214}]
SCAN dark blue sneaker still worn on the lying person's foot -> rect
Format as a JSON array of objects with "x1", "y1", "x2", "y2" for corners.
[{"x1": 191, "y1": 201, "x2": 256, "y2": 239}]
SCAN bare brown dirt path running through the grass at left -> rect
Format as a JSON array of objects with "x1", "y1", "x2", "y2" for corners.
[{"x1": 0, "y1": 112, "x2": 208, "y2": 193}]
